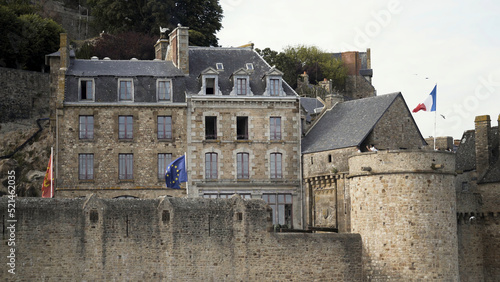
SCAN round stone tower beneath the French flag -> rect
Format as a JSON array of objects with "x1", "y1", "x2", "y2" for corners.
[{"x1": 349, "y1": 150, "x2": 459, "y2": 281}]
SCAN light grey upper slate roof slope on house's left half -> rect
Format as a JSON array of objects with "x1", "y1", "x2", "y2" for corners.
[{"x1": 66, "y1": 60, "x2": 184, "y2": 77}]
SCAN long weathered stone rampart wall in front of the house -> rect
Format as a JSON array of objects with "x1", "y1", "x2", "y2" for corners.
[{"x1": 0, "y1": 197, "x2": 362, "y2": 281}]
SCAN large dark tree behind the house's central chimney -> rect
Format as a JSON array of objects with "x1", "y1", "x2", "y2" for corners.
[{"x1": 88, "y1": 0, "x2": 222, "y2": 46}]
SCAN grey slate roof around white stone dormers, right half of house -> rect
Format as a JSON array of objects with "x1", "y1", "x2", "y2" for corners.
[{"x1": 186, "y1": 46, "x2": 297, "y2": 96}]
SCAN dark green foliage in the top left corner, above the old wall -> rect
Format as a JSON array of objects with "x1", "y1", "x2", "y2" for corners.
[{"x1": 0, "y1": 1, "x2": 64, "y2": 71}]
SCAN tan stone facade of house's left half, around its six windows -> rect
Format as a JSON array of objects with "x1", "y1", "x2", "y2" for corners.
[{"x1": 55, "y1": 104, "x2": 187, "y2": 198}]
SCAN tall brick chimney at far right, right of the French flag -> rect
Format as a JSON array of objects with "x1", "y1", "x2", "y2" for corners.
[{"x1": 474, "y1": 115, "x2": 491, "y2": 176}]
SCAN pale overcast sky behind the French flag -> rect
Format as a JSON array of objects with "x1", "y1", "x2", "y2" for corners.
[{"x1": 217, "y1": 0, "x2": 500, "y2": 139}]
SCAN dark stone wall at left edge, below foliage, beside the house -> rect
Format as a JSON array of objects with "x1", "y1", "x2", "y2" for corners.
[{"x1": 0, "y1": 68, "x2": 50, "y2": 123}]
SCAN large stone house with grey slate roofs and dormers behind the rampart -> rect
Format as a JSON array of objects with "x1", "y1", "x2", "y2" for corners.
[{"x1": 47, "y1": 27, "x2": 303, "y2": 227}]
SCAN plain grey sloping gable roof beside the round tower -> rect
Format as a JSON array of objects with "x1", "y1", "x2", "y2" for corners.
[{"x1": 302, "y1": 92, "x2": 402, "y2": 154}]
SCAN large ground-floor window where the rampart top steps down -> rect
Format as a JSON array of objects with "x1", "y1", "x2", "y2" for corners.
[{"x1": 262, "y1": 194, "x2": 292, "y2": 228}]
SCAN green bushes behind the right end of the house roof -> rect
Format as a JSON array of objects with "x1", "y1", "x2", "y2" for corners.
[{"x1": 256, "y1": 45, "x2": 347, "y2": 94}]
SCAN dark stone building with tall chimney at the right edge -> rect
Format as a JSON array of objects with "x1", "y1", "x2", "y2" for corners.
[{"x1": 455, "y1": 115, "x2": 500, "y2": 281}]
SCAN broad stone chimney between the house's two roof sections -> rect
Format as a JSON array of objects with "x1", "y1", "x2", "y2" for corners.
[{"x1": 165, "y1": 26, "x2": 189, "y2": 74}]
